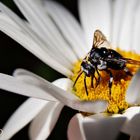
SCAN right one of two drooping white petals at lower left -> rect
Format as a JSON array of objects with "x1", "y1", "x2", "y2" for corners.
[{"x1": 29, "y1": 102, "x2": 63, "y2": 140}]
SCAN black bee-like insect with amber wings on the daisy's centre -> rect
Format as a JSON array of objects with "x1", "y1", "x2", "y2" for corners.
[{"x1": 73, "y1": 30, "x2": 140, "y2": 95}]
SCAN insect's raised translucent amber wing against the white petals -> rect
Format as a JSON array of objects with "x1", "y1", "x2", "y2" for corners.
[{"x1": 93, "y1": 30, "x2": 111, "y2": 49}]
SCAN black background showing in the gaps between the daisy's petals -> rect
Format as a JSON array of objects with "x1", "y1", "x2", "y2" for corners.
[{"x1": 0, "y1": 0, "x2": 128, "y2": 140}]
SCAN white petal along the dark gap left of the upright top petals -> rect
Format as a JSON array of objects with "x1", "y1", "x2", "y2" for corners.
[{"x1": 45, "y1": 1, "x2": 88, "y2": 58}]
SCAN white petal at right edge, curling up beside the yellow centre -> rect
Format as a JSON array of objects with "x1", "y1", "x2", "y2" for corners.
[{"x1": 126, "y1": 70, "x2": 140, "y2": 105}]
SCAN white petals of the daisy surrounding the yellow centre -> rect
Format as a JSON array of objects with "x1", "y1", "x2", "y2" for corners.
[{"x1": 0, "y1": 0, "x2": 140, "y2": 140}]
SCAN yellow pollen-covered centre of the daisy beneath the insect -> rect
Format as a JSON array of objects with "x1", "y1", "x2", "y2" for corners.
[{"x1": 71, "y1": 49, "x2": 140, "y2": 114}]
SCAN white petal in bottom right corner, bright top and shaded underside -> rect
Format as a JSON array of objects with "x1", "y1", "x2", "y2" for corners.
[{"x1": 122, "y1": 107, "x2": 140, "y2": 137}]
